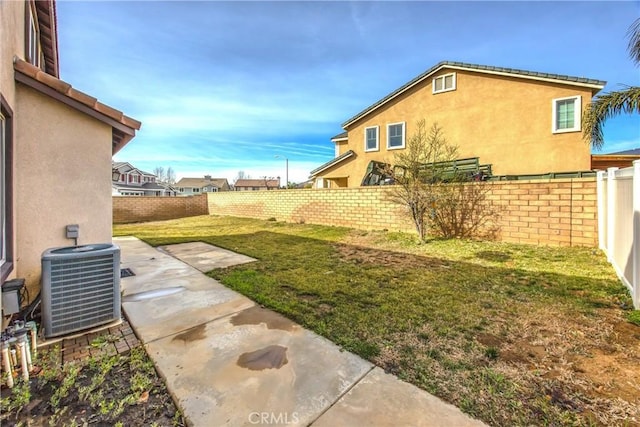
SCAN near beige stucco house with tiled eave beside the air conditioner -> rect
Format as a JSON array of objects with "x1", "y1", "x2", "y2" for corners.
[{"x1": 0, "y1": 0, "x2": 141, "y2": 308}]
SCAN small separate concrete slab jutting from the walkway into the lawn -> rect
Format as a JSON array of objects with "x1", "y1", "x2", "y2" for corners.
[{"x1": 159, "y1": 242, "x2": 256, "y2": 273}]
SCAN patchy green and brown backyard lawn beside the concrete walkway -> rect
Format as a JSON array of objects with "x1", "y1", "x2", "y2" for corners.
[{"x1": 114, "y1": 216, "x2": 640, "y2": 426}]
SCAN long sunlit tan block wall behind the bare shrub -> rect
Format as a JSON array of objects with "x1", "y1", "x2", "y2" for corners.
[{"x1": 208, "y1": 178, "x2": 598, "y2": 246}]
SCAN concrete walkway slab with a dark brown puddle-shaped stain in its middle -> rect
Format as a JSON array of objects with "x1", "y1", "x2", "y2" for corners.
[{"x1": 147, "y1": 307, "x2": 372, "y2": 426}]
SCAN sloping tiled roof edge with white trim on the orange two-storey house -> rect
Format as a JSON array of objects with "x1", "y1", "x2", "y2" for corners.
[{"x1": 342, "y1": 61, "x2": 607, "y2": 129}]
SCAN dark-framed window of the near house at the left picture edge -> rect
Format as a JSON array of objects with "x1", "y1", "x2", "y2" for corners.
[{"x1": 0, "y1": 96, "x2": 13, "y2": 282}]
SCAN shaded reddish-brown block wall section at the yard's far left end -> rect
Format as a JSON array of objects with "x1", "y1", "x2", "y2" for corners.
[{"x1": 113, "y1": 194, "x2": 209, "y2": 224}]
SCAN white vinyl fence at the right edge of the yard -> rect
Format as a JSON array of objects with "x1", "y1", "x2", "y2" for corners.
[{"x1": 598, "y1": 160, "x2": 640, "y2": 309}]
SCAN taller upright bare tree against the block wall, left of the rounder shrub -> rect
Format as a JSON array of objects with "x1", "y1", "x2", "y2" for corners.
[{"x1": 385, "y1": 119, "x2": 458, "y2": 241}]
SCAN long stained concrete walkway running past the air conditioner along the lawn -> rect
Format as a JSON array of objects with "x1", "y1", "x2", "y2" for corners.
[{"x1": 114, "y1": 237, "x2": 484, "y2": 427}]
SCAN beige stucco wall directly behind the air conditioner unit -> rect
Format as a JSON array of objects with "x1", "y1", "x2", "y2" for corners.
[{"x1": 14, "y1": 83, "x2": 112, "y2": 290}]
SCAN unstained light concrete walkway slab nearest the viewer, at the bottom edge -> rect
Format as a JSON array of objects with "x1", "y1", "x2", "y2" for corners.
[{"x1": 312, "y1": 368, "x2": 485, "y2": 427}]
